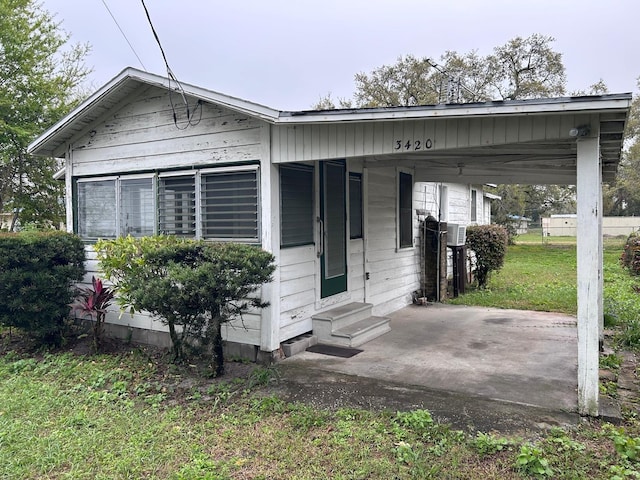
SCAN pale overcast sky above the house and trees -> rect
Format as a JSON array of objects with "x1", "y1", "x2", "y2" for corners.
[{"x1": 42, "y1": 0, "x2": 640, "y2": 110}]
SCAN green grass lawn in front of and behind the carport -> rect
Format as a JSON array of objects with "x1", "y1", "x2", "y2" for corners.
[{"x1": 0, "y1": 244, "x2": 640, "y2": 480}]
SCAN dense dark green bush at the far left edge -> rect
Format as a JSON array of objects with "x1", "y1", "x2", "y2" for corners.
[{"x1": 0, "y1": 231, "x2": 85, "y2": 344}]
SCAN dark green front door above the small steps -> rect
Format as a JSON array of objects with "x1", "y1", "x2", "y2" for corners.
[{"x1": 320, "y1": 161, "x2": 347, "y2": 298}]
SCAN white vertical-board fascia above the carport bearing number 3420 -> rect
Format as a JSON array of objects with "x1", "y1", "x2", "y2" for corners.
[{"x1": 272, "y1": 114, "x2": 590, "y2": 163}]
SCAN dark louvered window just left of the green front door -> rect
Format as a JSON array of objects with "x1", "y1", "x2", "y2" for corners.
[{"x1": 280, "y1": 165, "x2": 314, "y2": 247}]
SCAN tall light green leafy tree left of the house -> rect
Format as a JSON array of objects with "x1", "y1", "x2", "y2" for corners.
[{"x1": 0, "y1": 0, "x2": 90, "y2": 231}]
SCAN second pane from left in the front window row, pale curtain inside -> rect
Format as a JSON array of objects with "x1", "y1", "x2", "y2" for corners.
[{"x1": 119, "y1": 177, "x2": 156, "y2": 237}]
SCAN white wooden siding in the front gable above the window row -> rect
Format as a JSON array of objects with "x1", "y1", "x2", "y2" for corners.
[{"x1": 72, "y1": 89, "x2": 262, "y2": 177}]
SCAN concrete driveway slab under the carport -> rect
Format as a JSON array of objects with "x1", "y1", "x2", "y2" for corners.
[{"x1": 272, "y1": 304, "x2": 578, "y2": 430}]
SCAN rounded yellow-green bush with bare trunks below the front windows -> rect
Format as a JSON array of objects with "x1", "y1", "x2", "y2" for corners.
[{"x1": 96, "y1": 236, "x2": 275, "y2": 375}]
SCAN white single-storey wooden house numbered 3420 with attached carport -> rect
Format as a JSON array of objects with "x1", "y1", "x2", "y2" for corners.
[{"x1": 29, "y1": 68, "x2": 631, "y2": 412}]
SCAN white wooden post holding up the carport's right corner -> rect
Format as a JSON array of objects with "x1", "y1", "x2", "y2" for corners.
[{"x1": 576, "y1": 132, "x2": 603, "y2": 417}]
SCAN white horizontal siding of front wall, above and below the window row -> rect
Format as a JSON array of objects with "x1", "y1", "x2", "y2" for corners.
[{"x1": 67, "y1": 87, "x2": 269, "y2": 345}]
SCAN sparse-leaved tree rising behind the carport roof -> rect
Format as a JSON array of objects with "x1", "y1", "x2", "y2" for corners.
[{"x1": 318, "y1": 34, "x2": 566, "y2": 107}]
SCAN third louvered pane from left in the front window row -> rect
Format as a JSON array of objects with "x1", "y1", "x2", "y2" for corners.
[{"x1": 158, "y1": 175, "x2": 196, "y2": 237}]
